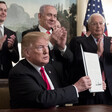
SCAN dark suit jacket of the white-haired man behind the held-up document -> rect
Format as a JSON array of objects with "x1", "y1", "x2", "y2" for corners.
[{"x1": 70, "y1": 35, "x2": 112, "y2": 104}]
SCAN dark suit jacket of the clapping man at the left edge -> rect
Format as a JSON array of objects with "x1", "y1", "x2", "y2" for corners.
[{"x1": 0, "y1": 27, "x2": 19, "y2": 78}]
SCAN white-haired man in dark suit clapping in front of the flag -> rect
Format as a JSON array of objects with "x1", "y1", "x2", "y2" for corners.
[{"x1": 70, "y1": 13, "x2": 112, "y2": 104}]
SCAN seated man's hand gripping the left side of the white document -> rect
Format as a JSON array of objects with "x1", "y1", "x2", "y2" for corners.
[{"x1": 74, "y1": 76, "x2": 91, "y2": 92}]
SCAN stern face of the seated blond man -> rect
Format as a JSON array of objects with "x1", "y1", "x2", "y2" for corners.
[{"x1": 27, "y1": 38, "x2": 49, "y2": 66}]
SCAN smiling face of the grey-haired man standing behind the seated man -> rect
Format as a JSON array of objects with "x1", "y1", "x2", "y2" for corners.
[{"x1": 38, "y1": 6, "x2": 57, "y2": 30}]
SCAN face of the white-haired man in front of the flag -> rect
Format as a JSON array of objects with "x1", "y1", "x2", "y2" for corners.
[{"x1": 89, "y1": 16, "x2": 105, "y2": 38}]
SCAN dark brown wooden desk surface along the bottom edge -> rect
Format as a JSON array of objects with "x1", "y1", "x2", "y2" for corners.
[{"x1": 0, "y1": 105, "x2": 112, "y2": 112}]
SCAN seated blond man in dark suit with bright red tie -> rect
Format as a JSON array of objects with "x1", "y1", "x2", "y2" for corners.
[{"x1": 9, "y1": 32, "x2": 91, "y2": 108}]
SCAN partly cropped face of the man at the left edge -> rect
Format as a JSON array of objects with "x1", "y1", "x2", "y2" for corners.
[{"x1": 0, "y1": 3, "x2": 7, "y2": 23}]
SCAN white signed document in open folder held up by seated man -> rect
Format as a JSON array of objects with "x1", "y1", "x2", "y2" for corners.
[{"x1": 81, "y1": 46, "x2": 104, "y2": 92}]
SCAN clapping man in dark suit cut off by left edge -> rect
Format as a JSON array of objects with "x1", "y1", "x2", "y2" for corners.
[{"x1": 0, "y1": 1, "x2": 19, "y2": 78}]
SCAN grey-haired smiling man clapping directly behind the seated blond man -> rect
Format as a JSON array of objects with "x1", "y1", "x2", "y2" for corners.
[{"x1": 22, "y1": 5, "x2": 73, "y2": 85}]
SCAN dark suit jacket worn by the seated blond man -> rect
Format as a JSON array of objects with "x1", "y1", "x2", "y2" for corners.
[{"x1": 9, "y1": 59, "x2": 78, "y2": 108}]
